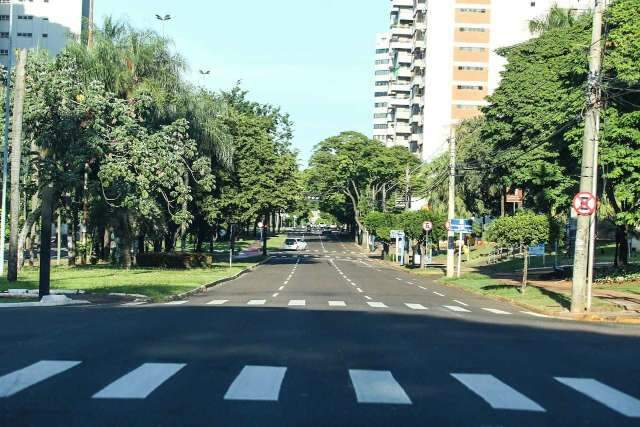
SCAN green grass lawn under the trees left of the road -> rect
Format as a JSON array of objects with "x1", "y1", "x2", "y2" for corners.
[{"x1": 0, "y1": 258, "x2": 260, "y2": 300}]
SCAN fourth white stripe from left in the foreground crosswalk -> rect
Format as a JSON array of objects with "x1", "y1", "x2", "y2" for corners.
[{"x1": 349, "y1": 369, "x2": 411, "y2": 405}]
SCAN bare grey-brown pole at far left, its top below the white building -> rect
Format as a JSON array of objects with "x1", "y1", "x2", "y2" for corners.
[{"x1": 2, "y1": 49, "x2": 27, "y2": 282}]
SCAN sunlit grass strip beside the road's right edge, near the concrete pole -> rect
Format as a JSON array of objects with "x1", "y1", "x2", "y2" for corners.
[{"x1": 441, "y1": 273, "x2": 619, "y2": 312}]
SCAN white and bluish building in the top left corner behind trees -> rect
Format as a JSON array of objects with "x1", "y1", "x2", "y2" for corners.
[{"x1": 0, "y1": 0, "x2": 94, "y2": 65}]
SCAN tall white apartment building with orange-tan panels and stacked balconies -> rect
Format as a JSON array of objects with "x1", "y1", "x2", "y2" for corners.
[{"x1": 378, "y1": 0, "x2": 593, "y2": 161}]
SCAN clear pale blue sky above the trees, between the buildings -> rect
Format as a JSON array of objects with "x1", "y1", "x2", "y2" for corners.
[{"x1": 95, "y1": 0, "x2": 389, "y2": 164}]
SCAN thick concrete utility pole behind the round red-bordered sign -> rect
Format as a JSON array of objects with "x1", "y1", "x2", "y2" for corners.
[{"x1": 571, "y1": 0, "x2": 605, "y2": 313}]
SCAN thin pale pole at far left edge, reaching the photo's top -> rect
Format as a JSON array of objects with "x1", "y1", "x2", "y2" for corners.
[{"x1": 0, "y1": 1, "x2": 13, "y2": 276}]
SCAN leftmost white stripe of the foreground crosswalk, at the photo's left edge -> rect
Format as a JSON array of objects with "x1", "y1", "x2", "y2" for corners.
[{"x1": 0, "y1": 360, "x2": 81, "y2": 397}]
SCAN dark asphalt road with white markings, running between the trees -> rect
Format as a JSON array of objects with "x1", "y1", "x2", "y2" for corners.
[{"x1": 0, "y1": 236, "x2": 640, "y2": 427}]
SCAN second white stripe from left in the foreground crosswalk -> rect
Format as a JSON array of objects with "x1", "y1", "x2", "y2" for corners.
[{"x1": 93, "y1": 363, "x2": 186, "y2": 399}]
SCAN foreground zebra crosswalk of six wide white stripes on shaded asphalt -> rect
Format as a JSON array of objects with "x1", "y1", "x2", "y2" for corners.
[{"x1": 0, "y1": 360, "x2": 640, "y2": 418}]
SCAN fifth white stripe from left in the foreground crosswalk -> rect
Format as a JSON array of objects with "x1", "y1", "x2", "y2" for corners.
[{"x1": 451, "y1": 374, "x2": 546, "y2": 412}]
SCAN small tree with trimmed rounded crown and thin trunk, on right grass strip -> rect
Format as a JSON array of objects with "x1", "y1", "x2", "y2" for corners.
[{"x1": 489, "y1": 211, "x2": 552, "y2": 292}]
